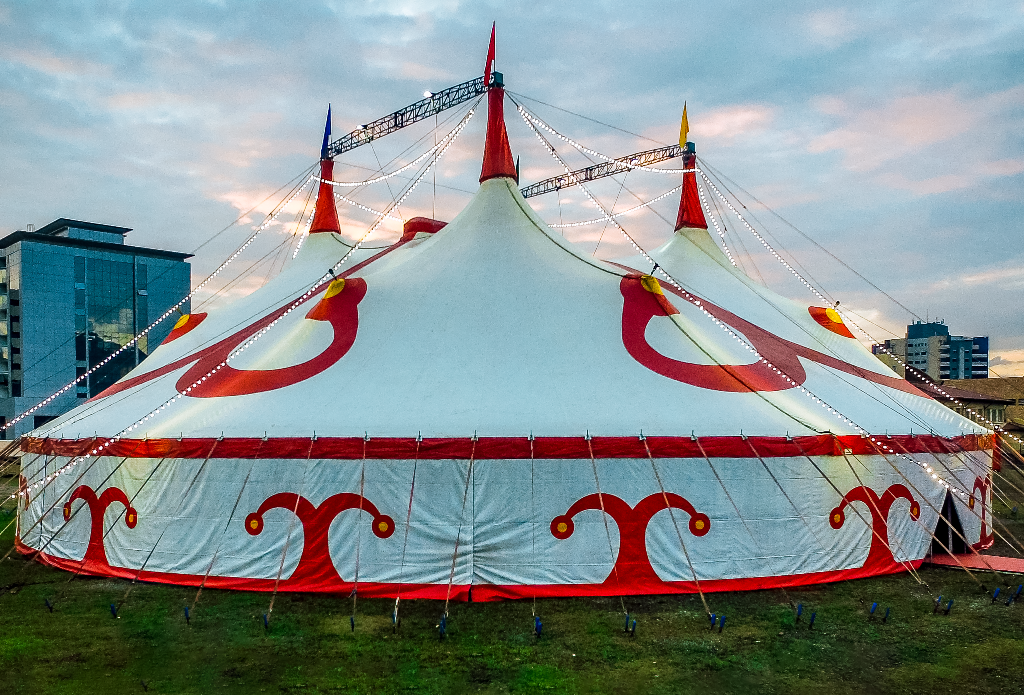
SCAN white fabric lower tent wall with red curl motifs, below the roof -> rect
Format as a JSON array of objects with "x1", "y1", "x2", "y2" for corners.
[{"x1": 14, "y1": 454, "x2": 984, "y2": 598}]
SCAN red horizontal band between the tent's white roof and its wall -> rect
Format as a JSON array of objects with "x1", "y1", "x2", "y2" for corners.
[{"x1": 22, "y1": 434, "x2": 992, "y2": 460}]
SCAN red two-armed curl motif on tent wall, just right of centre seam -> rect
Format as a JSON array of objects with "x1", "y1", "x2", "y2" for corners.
[{"x1": 551, "y1": 492, "x2": 711, "y2": 589}]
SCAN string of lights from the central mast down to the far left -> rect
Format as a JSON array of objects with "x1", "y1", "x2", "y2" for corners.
[{"x1": 7, "y1": 105, "x2": 473, "y2": 499}]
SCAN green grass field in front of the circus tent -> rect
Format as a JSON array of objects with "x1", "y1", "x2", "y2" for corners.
[{"x1": 0, "y1": 481, "x2": 1024, "y2": 695}]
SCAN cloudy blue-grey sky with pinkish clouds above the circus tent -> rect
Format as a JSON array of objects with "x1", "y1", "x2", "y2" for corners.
[{"x1": 6, "y1": 0, "x2": 1024, "y2": 376}]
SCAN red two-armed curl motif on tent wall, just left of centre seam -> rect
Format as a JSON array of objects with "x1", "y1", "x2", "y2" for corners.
[{"x1": 246, "y1": 492, "x2": 394, "y2": 587}]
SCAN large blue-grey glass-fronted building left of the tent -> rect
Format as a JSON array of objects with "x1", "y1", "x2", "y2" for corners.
[{"x1": 0, "y1": 218, "x2": 191, "y2": 439}]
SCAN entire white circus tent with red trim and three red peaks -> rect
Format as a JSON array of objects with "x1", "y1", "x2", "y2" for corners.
[{"x1": 18, "y1": 72, "x2": 992, "y2": 600}]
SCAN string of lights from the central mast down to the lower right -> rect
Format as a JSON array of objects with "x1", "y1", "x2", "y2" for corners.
[{"x1": 520, "y1": 107, "x2": 971, "y2": 501}]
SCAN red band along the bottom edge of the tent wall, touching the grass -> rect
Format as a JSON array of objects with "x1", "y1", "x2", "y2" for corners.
[{"x1": 9, "y1": 538, "x2": 924, "y2": 601}]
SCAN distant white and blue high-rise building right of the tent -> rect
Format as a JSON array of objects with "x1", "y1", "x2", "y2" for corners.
[{"x1": 871, "y1": 321, "x2": 988, "y2": 381}]
